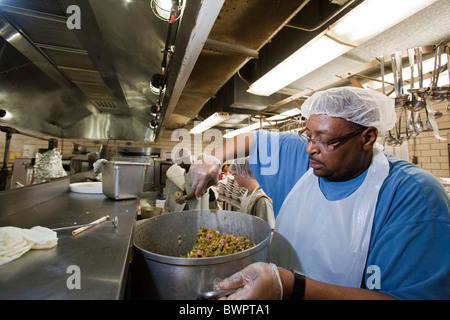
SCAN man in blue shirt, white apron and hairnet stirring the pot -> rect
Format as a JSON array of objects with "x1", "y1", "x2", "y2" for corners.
[{"x1": 193, "y1": 88, "x2": 450, "y2": 299}]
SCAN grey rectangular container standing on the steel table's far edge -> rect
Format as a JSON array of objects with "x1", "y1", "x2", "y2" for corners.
[{"x1": 102, "y1": 161, "x2": 150, "y2": 200}]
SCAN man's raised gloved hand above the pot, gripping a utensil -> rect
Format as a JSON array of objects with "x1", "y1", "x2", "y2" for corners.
[{"x1": 189, "y1": 155, "x2": 221, "y2": 198}]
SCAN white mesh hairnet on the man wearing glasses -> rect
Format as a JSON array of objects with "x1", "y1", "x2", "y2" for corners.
[{"x1": 302, "y1": 87, "x2": 397, "y2": 134}]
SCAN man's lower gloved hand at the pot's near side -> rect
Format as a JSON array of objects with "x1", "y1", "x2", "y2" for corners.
[{"x1": 216, "y1": 262, "x2": 283, "y2": 300}]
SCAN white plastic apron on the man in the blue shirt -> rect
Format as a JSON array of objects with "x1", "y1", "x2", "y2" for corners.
[{"x1": 271, "y1": 149, "x2": 389, "y2": 287}]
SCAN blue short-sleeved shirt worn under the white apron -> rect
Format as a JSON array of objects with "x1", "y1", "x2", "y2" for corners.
[{"x1": 250, "y1": 131, "x2": 450, "y2": 299}]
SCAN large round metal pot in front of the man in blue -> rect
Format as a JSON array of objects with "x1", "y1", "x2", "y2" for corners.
[{"x1": 131, "y1": 210, "x2": 271, "y2": 300}]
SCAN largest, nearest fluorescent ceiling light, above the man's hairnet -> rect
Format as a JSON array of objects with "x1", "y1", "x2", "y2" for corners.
[{"x1": 247, "y1": 0, "x2": 437, "y2": 96}]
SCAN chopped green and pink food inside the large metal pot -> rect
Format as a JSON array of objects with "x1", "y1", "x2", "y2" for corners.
[{"x1": 185, "y1": 227, "x2": 255, "y2": 258}]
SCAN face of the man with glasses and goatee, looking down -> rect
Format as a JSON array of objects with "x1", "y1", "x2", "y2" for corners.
[{"x1": 305, "y1": 115, "x2": 371, "y2": 181}]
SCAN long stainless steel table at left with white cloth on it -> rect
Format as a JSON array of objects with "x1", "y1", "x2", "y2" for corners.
[{"x1": 0, "y1": 181, "x2": 139, "y2": 299}]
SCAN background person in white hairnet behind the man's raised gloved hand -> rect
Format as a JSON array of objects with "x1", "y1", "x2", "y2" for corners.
[{"x1": 174, "y1": 148, "x2": 210, "y2": 210}]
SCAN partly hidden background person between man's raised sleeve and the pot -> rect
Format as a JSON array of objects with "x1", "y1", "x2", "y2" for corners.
[{"x1": 230, "y1": 157, "x2": 275, "y2": 230}]
